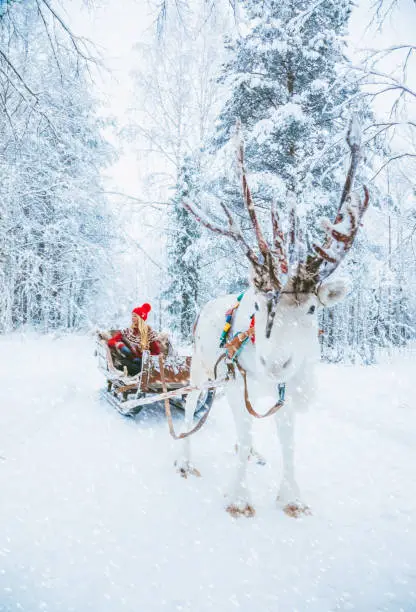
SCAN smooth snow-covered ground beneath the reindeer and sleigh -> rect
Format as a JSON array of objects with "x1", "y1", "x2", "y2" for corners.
[{"x1": 0, "y1": 335, "x2": 416, "y2": 612}]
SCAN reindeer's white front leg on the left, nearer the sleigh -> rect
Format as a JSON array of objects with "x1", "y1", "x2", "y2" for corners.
[{"x1": 226, "y1": 381, "x2": 255, "y2": 517}]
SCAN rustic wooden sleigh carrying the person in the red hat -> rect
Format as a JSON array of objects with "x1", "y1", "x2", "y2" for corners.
[{"x1": 96, "y1": 330, "x2": 217, "y2": 416}]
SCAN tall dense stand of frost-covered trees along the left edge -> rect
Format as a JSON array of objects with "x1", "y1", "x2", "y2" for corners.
[{"x1": 0, "y1": 2, "x2": 113, "y2": 331}]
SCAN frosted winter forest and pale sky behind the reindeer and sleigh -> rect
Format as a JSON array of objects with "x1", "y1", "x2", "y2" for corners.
[{"x1": 0, "y1": 0, "x2": 416, "y2": 364}]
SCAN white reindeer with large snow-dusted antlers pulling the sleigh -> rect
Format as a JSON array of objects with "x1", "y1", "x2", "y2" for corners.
[{"x1": 176, "y1": 122, "x2": 369, "y2": 516}]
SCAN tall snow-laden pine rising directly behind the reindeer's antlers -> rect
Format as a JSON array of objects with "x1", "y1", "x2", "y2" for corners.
[{"x1": 213, "y1": 0, "x2": 360, "y2": 244}]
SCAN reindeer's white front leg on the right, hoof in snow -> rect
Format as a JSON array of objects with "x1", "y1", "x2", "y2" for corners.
[{"x1": 275, "y1": 402, "x2": 310, "y2": 517}]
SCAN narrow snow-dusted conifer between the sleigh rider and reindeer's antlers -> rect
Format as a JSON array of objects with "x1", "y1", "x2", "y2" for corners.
[{"x1": 163, "y1": 157, "x2": 201, "y2": 341}]
